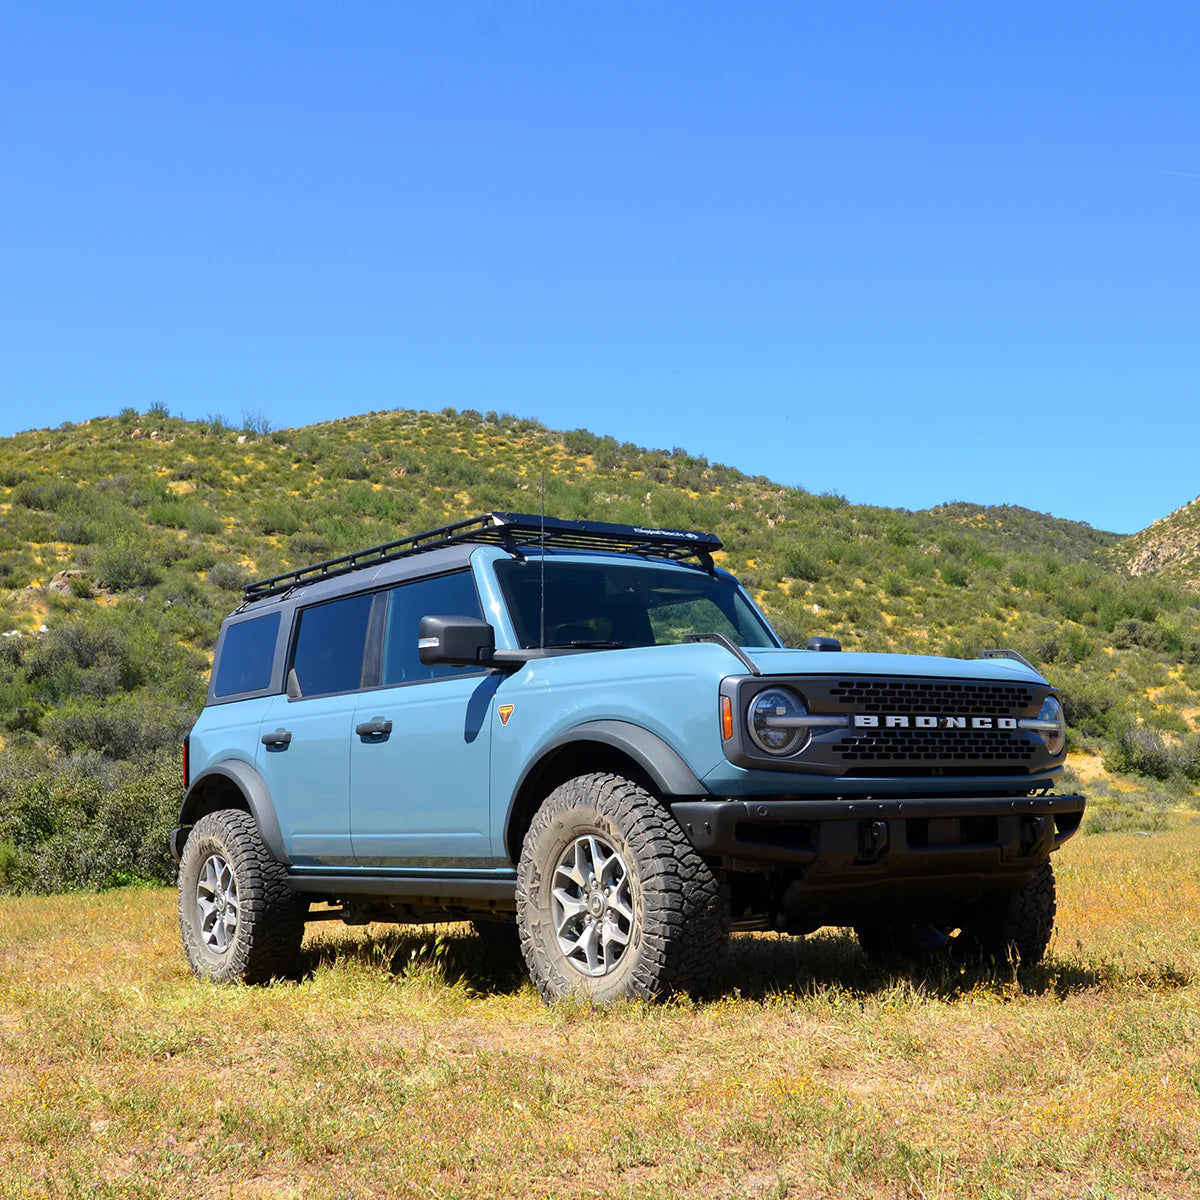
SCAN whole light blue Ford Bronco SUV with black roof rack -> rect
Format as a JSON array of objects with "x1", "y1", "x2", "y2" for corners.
[{"x1": 172, "y1": 512, "x2": 1084, "y2": 1002}]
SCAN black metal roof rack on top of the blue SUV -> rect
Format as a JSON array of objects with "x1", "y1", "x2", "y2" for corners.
[{"x1": 241, "y1": 512, "x2": 721, "y2": 604}]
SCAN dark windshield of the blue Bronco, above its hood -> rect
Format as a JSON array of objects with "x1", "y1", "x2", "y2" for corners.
[{"x1": 496, "y1": 558, "x2": 779, "y2": 648}]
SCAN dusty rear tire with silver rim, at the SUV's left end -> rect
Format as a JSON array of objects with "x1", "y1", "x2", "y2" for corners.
[{"x1": 179, "y1": 809, "x2": 308, "y2": 984}]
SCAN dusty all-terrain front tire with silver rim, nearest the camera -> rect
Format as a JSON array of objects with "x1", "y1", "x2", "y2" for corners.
[{"x1": 517, "y1": 774, "x2": 728, "y2": 1003}]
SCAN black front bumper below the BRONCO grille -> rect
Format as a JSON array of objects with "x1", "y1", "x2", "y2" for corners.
[{"x1": 671, "y1": 794, "x2": 1086, "y2": 884}]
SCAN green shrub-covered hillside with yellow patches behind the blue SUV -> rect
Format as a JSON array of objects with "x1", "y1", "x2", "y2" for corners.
[{"x1": 0, "y1": 407, "x2": 1200, "y2": 890}]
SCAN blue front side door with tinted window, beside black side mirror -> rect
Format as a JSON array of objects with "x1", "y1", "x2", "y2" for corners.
[{"x1": 350, "y1": 571, "x2": 502, "y2": 870}]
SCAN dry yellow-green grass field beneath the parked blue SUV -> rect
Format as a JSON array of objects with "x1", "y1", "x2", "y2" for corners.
[{"x1": 0, "y1": 818, "x2": 1200, "y2": 1198}]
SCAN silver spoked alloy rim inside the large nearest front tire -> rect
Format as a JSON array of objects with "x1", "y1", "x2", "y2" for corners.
[{"x1": 551, "y1": 834, "x2": 634, "y2": 977}]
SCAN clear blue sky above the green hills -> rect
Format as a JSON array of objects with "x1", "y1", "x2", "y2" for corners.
[{"x1": 0, "y1": 0, "x2": 1200, "y2": 532}]
